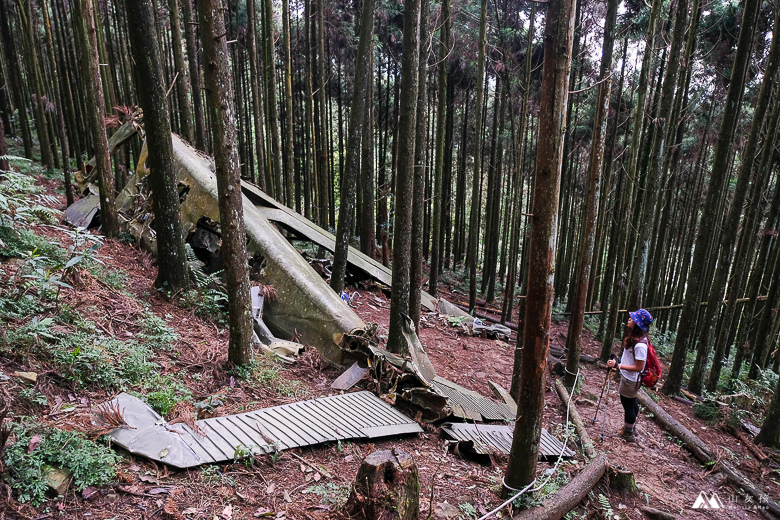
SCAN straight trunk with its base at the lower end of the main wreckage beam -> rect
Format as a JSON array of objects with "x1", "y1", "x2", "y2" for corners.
[{"x1": 386, "y1": 0, "x2": 420, "y2": 352}]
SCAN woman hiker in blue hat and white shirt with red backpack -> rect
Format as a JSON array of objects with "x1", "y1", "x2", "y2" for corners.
[{"x1": 607, "y1": 309, "x2": 653, "y2": 442}]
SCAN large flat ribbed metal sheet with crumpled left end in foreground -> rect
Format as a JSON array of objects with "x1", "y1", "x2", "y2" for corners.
[{"x1": 103, "y1": 391, "x2": 422, "y2": 468}]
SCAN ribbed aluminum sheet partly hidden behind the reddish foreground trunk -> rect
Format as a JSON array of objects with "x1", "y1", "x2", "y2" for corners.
[{"x1": 442, "y1": 423, "x2": 574, "y2": 459}]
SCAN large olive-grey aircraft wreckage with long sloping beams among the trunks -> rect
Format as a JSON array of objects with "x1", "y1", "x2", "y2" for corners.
[{"x1": 66, "y1": 120, "x2": 515, "y2": 434}]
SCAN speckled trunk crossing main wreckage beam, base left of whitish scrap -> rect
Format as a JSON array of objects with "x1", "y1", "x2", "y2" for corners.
[{"x1": 198, "y1": 0, "x2": 252, "y2": 365}]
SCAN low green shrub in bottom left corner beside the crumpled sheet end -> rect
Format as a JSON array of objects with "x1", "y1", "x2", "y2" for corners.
[{"x1": 3, "y1": 422, "x2": 119, "y2": 505}]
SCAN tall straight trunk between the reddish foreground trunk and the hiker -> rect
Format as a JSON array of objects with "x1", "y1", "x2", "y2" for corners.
[{"x1": 566, "y1": 0, "x2": 618, "y2": 388}]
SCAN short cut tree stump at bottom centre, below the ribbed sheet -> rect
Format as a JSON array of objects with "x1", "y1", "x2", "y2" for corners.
[{"x1": 343, "y1": 448, "x2": 420, "y2": 520}]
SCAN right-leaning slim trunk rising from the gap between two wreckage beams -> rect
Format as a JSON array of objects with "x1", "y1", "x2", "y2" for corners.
[{"x1": 330, "y1": 0, "x2": 376, "y2": 292}]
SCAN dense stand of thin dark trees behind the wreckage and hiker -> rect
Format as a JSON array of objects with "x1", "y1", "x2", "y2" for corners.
[{"x1": 0, "y1": 0, "x2": 780, "y2": 444}]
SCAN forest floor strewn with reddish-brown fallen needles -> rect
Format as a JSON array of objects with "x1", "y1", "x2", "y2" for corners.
[{"x1": 0, "y1": 167, "x2": 780, "y2": 520}]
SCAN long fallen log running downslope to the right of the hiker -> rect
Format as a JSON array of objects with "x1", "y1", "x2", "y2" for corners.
[{"x1": 637, "y1": 390, "x2": 780, "y2": 517}]
